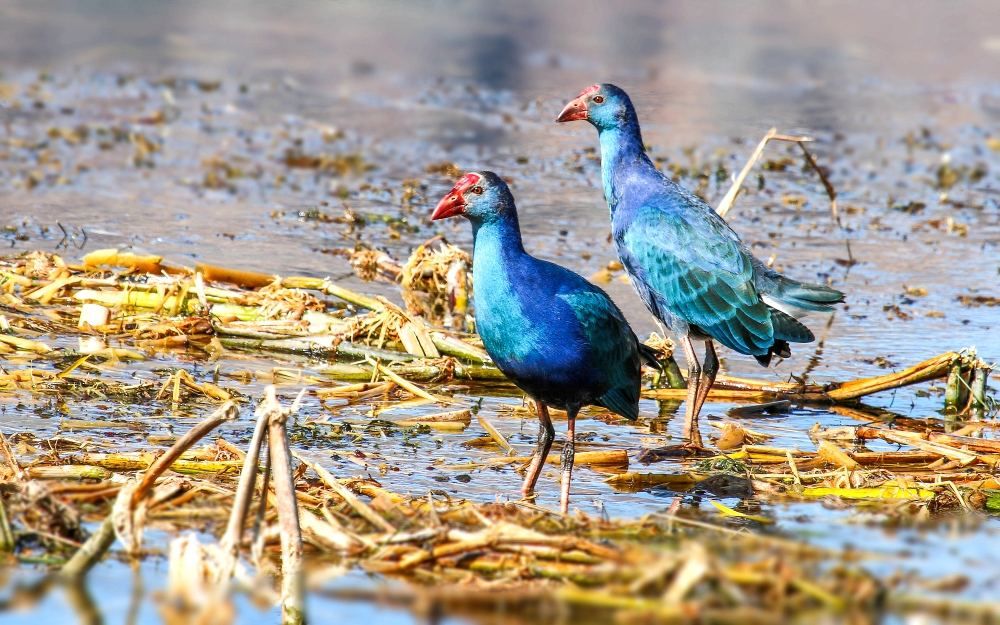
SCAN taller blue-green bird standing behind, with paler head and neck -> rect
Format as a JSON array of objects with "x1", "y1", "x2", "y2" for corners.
[{"x1": 556, "y1": 84, "x2": 844, "y2": 448}]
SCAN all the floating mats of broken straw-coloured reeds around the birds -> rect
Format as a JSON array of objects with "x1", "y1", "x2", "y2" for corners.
[{"x1": 0, "y1": 240, "x2": 1000, "y2": 623}]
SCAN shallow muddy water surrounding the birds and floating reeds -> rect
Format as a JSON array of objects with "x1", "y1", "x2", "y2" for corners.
[{"x1": 0, "y1": 1, "x2": 1000, "y2": 622}]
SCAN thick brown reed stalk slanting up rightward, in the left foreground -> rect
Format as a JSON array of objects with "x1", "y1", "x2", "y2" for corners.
[{"x1": 59, "y1": 401, "x2": 239, "y2": 580}]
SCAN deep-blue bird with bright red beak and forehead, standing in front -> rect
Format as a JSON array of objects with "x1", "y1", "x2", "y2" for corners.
[{"x1": 431, "y1": 171, "x2": 656, "y2": 514}]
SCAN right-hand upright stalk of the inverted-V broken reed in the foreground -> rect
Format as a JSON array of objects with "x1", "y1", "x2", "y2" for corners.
[{"x1": 258, "y1": 385, "x2": 305, "y2": 625}]
